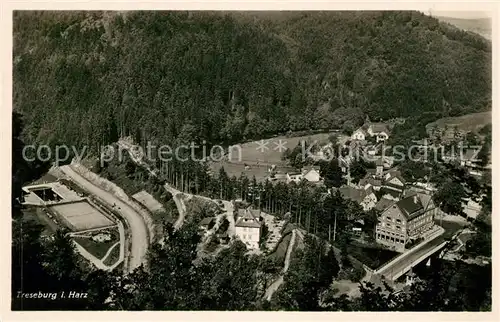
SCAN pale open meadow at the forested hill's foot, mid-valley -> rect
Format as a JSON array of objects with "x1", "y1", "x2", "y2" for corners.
[{"x1": 210, "y1": 132, "x2": 339, "y2": 181}]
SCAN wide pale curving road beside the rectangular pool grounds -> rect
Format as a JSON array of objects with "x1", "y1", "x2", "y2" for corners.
[{"x1": 60, "y1": 165, "x2": 149, "y2": 272}]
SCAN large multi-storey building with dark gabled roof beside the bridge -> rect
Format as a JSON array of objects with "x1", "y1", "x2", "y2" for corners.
[{"x1": 375, "y1": 193, "x2": 437, "y2": 252}]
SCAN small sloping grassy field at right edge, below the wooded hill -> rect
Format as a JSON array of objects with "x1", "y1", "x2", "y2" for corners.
[{"x1": 425, "y1": 111, "x2": 492, "y2": 136}]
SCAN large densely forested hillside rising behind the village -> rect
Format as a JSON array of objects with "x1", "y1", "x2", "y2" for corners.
[{"x1": 13, "y1": 11, "x2": 491, "y2": 147}]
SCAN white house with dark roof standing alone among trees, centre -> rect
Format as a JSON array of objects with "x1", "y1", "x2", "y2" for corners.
[{"x1": 235, "y1": 208, "x2": 262, "y2": 249}]
